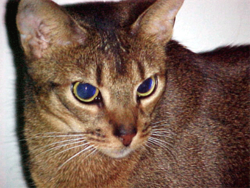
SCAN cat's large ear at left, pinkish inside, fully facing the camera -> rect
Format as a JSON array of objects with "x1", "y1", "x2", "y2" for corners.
[{"x1": 17, "y1": 0, "x2": 87, "y2": 58}]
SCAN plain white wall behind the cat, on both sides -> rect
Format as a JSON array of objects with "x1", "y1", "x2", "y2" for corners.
[{"x1": 0, "y1": 0, "x2": 250, "y2": 188}]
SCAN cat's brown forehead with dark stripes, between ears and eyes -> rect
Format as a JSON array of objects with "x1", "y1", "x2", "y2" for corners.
[{"x1": 56, "y1": 27, "x2": 165, "y2": 90}]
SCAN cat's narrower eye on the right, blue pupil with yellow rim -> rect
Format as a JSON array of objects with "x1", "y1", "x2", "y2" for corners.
[{"x1": 137, "y1": 76, "x2": 156, "y2": 97}]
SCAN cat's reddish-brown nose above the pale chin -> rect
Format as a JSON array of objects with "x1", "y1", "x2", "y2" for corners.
[{"x1": 114, "y1": 125, "x2": 137, "y2": 147}]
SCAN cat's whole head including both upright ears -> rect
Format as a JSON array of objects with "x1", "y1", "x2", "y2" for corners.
[{"x1": 17, "y1": 0, "x2": 183, "y2": 158}]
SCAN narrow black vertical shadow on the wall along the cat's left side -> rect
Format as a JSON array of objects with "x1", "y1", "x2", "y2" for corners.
[{"x1": 5, "y1": 0, "x2": 35, "y2": 188}]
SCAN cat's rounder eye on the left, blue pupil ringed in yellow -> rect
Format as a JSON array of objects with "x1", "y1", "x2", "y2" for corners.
[{"x1": 72, "y1": 82, "x2": 99, "y2": 103}]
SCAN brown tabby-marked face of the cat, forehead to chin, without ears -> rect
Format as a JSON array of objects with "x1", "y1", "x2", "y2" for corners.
[{"x1": 28, "y1": 31, "x2": 166, "y2": 158}]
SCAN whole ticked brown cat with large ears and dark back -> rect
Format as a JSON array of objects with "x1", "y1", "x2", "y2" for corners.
[{"x1": 17, "y1": 0, "x2": 250, "y2": 188}]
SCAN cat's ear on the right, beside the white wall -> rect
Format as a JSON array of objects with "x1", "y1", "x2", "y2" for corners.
[{"x1": 131, "y1": 0, "x2": 184, "y2": 45}]
